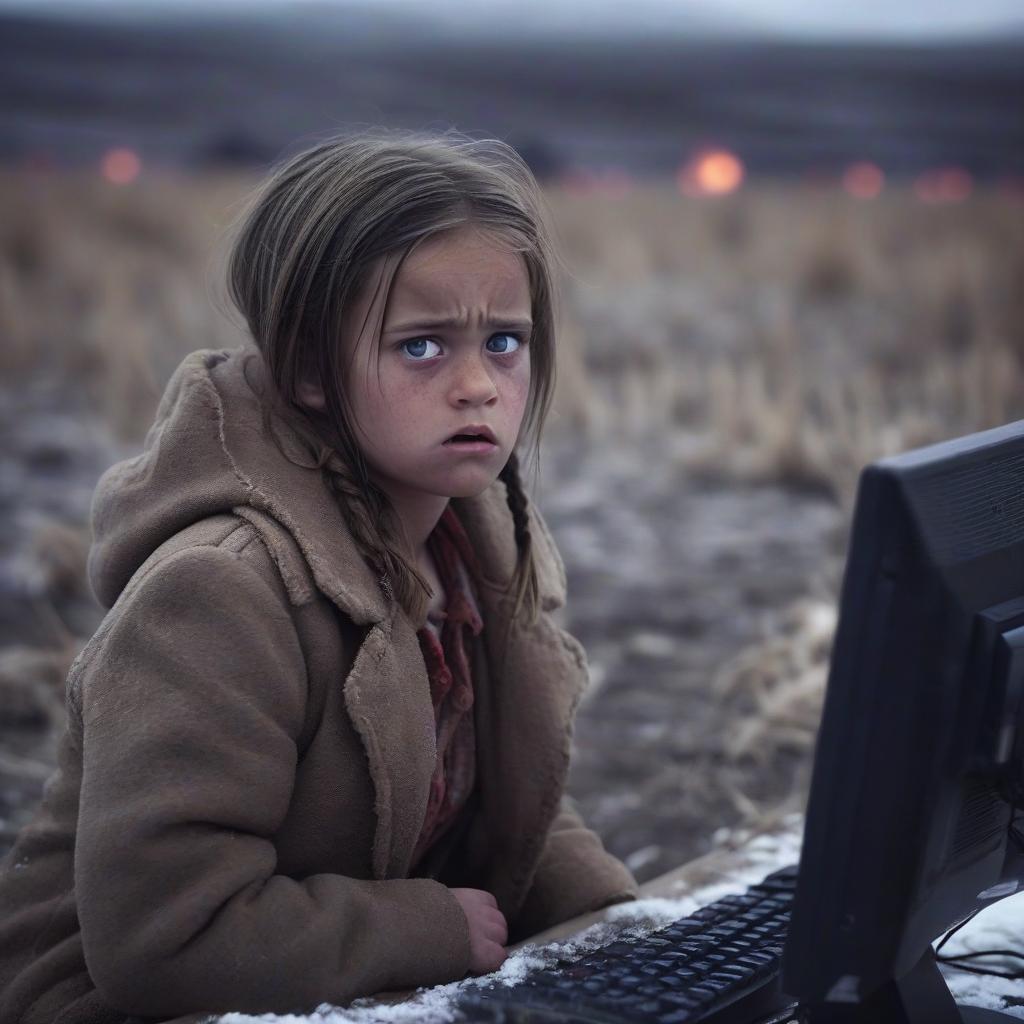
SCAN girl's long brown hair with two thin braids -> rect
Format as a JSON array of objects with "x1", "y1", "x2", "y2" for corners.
[{"x1": 227, "y1": 128, "x2": 559, "y2": 625}]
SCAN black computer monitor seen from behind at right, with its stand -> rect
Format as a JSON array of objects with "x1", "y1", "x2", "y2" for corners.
[{"x1": 782, "y1": 421, "x2": 1024, "y2": 1024}]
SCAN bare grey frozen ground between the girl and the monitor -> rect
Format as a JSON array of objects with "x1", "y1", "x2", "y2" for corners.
[{"x1": 538, "y1": 432, "x2": 843, "y2": 881}]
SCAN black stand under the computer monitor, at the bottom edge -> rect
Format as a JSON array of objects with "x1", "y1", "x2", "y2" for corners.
[{"x1": 801, "y1": 947, "x2": 1017, "y2": 1024}]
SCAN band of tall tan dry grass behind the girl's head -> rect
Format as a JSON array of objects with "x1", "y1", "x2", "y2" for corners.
[{"x1": 0, "y1": 171, "x2": 1024, "y2": 497}]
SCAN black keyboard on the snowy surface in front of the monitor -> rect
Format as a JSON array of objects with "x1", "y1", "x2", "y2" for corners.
[{"x1": 456, "y1": 866, "x2": 797, "y2": 1024}]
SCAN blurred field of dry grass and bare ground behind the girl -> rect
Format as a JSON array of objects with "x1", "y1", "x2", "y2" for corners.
[{"x1": 0, "y1": 171, "x2": 1024, "y2": 878}]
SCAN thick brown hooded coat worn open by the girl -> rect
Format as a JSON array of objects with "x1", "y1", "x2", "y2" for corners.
[{"x1": 0, "y1": 344, "x2": 637, "y2": 1024}]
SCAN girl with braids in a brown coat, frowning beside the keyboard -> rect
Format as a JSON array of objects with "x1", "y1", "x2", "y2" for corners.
[{"x1": 0, "y1": 131, "x2": 637, "y2": 1024}]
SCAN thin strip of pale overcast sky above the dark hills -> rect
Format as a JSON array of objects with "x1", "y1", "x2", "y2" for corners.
[{"x1": 6, "y1": 0, "x2": 1024, "y2": 39}]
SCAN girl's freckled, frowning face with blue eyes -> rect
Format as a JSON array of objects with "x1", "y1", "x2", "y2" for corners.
[{"x1": 301, "y1": 225, "x2": 531, "y2": 520}]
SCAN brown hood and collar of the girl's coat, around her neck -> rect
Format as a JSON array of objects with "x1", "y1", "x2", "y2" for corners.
[{"x1": 88, "y1": 344, "x2": 565, "y2": 624}]
